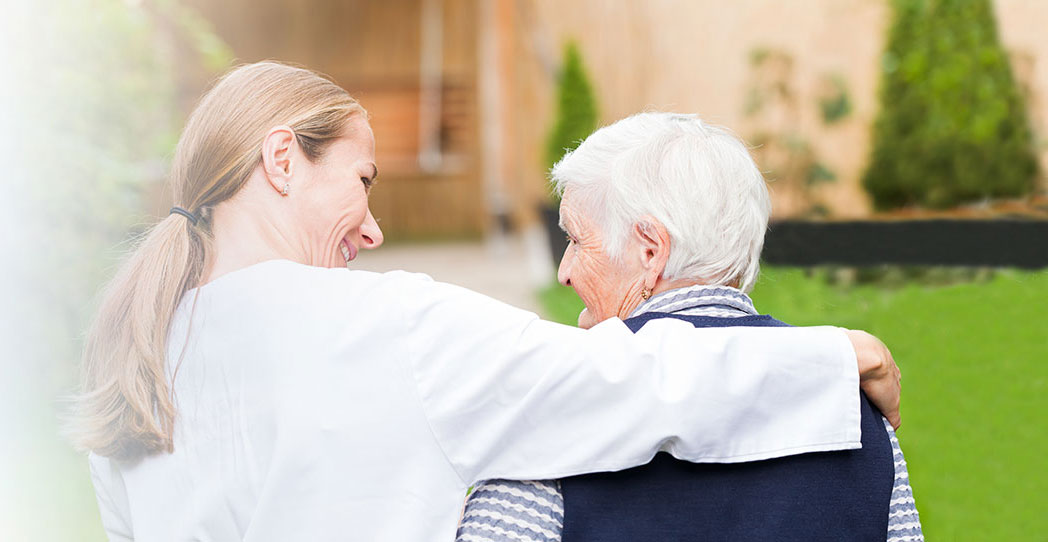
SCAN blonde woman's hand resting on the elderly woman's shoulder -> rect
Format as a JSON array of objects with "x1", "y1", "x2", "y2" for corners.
[{"x1": 845, "y1": 329, "x2": 902, "y2": 429}]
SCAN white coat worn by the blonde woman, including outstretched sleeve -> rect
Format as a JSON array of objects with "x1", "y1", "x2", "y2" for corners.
[{"x1": 90, "y1": 261, "x2": 859, "y2": 542}]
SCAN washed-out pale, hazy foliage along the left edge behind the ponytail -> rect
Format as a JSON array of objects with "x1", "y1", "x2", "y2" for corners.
[{"x1": 0, "y1": 0, "x2": 230, "y2": 541}]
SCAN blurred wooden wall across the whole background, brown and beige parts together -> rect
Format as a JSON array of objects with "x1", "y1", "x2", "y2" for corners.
[{"x1": 171, "y1": 0, "x2": 1048, "y2": 234}]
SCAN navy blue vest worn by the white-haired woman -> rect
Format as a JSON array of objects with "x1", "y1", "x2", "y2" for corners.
[{"x1": 561, "y1": 312, "x2": 895, "y2": 542}]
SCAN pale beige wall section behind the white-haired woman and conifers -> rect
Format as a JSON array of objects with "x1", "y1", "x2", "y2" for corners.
[{"x1": 503, "y1": 0, "x2": 1048, "y2": 218}]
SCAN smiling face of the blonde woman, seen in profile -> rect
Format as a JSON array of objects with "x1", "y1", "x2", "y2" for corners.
[{"x1": 286, "y1": 115, "x2": 383, "y2": 267}]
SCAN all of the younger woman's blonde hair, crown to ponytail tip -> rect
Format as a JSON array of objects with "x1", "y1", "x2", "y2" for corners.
[{"x1": 71, "y1": 62, "x2": 366, "y2": 457}]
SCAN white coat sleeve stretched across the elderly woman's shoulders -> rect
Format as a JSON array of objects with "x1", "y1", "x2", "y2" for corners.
[{"x1": 397, "y1": 274, "x2": 860, "y2": 483}]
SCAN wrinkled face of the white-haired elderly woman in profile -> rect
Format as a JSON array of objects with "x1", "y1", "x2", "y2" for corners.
[{"x1": 556, "y1": 190, "x2": 643, "y2": 328}]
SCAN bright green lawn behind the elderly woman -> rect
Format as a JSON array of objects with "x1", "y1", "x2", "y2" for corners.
[{"x1": 541, "y1": 267, "x2": 1048, "y2": 540}]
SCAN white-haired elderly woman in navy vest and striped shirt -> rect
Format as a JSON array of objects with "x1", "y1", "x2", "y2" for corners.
[{"x1": 458, "y1": 113, "x2": 921, "y2": 542}]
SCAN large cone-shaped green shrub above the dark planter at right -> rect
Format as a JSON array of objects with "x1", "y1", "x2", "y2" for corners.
[{"x1": 863, "y1": 0, "x2": 1038, "y2": 209}]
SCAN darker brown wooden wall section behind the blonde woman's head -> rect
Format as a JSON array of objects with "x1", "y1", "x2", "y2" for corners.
[{"x1": 181, "y1": 0, "x2": 485, "y2": 240}]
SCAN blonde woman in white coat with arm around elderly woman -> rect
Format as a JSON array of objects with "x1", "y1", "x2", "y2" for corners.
[{"x1": 78, "y1": 63, "x2": 898, "y2": 541}]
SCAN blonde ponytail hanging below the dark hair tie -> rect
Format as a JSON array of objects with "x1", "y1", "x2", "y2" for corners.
[{"x1": 78, "y1": 215, "x2": 208, "y2": 456}]
